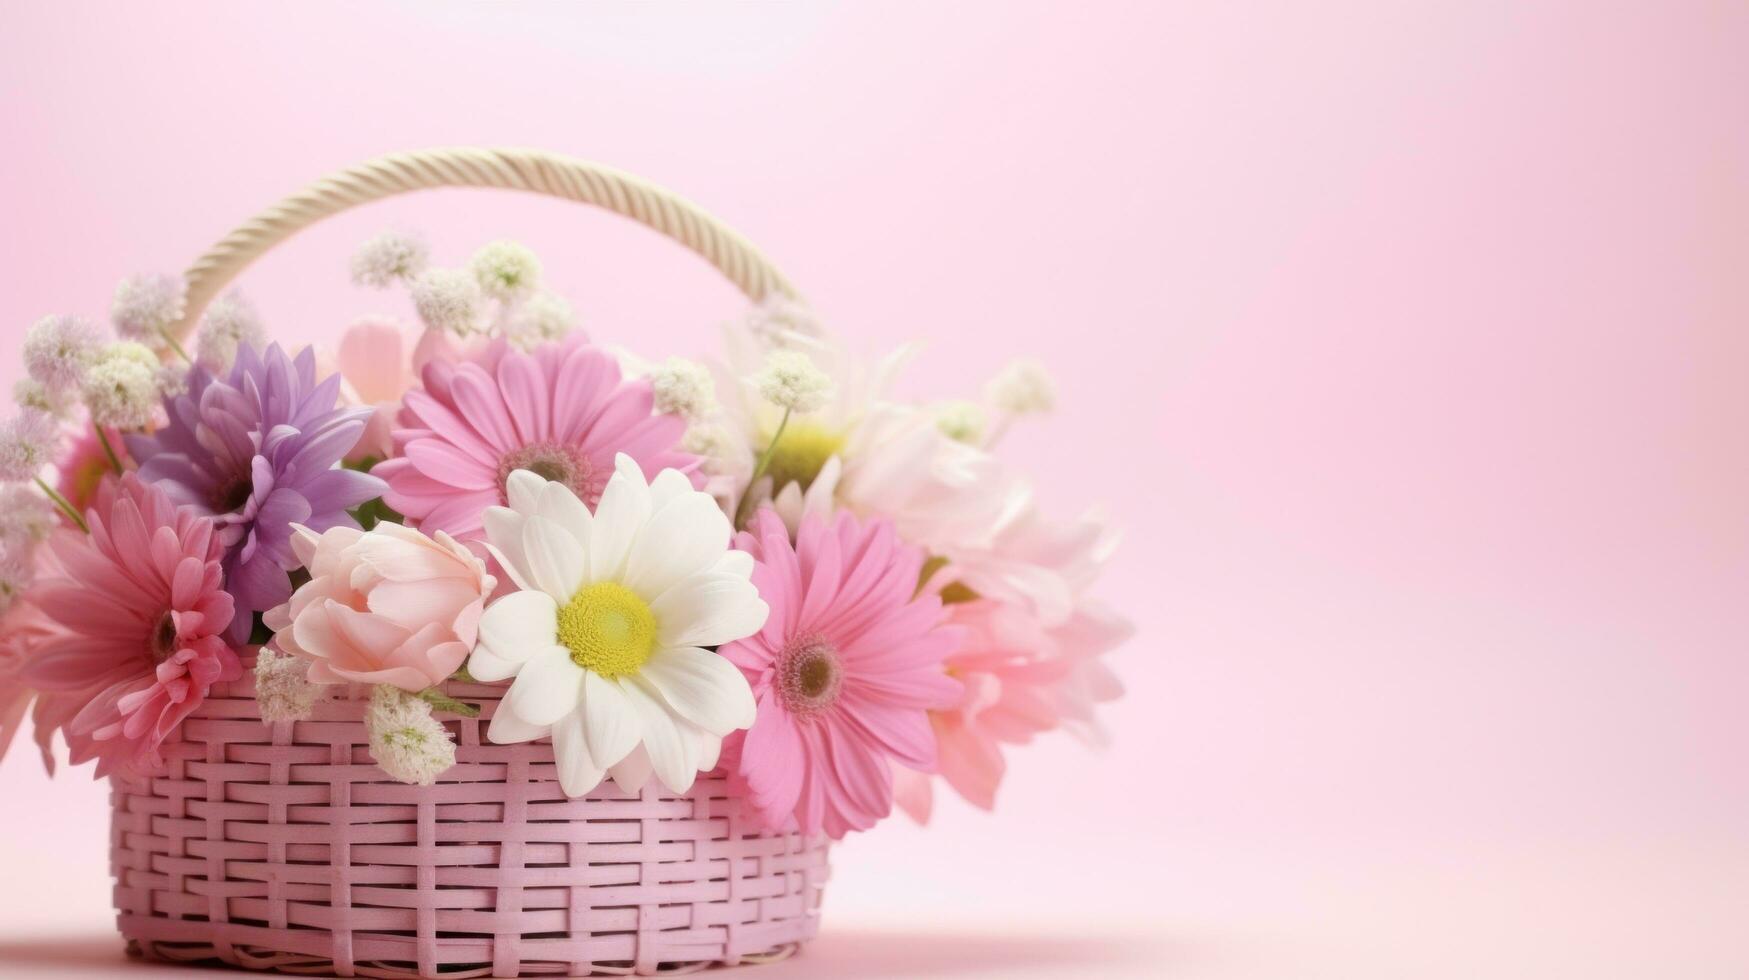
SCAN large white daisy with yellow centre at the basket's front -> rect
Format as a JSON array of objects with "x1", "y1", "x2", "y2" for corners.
[{"x1": 467, "y1": 455, "x2": 770, "y2": 796}]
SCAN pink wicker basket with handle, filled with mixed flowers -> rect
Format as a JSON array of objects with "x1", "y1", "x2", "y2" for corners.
[{"x1": 0, "y1": 151, "x2": 1128, "y2": 977}]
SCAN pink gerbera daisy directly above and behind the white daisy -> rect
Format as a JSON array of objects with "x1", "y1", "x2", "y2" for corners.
[{"x1": 373, "y1": 340, "x2": 700, "y2": 539}]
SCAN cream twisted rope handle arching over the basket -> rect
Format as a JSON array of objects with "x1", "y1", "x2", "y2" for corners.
[{"x1": 171, "y1": 147, "x2": 794, "y2": 338}]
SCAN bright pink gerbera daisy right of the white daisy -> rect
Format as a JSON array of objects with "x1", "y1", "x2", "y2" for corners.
[{"x1": 719, "y1": 509, "x2": 960, "y2": 838}]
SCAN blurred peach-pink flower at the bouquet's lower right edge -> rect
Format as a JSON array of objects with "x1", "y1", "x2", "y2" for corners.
[{"x1": 894, "y1": 599, "x2": 1132, "y2": 823}]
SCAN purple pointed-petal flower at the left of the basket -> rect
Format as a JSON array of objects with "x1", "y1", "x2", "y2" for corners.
[{"x1": 128, "y1": 345, "x2": 387, "y2": 642}]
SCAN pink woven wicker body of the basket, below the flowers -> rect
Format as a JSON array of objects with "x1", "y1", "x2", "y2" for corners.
[{"x1": 110, "y1": 676, "x2": 827, "y2": 978}]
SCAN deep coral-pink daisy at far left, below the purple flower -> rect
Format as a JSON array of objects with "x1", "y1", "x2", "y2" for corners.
[{"x1": 24, "y1": 474, "x2": 241, "y2": 777}]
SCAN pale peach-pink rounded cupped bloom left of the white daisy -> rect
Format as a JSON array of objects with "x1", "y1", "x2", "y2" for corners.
[{"x1": 264, "y1": 523, "x2": 497, "y2": 691}]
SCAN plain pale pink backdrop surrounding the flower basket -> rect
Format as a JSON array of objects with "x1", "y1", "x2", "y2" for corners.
[{"x1": 0, "y1": 0, "x2": 1749, "y2": 978}]
